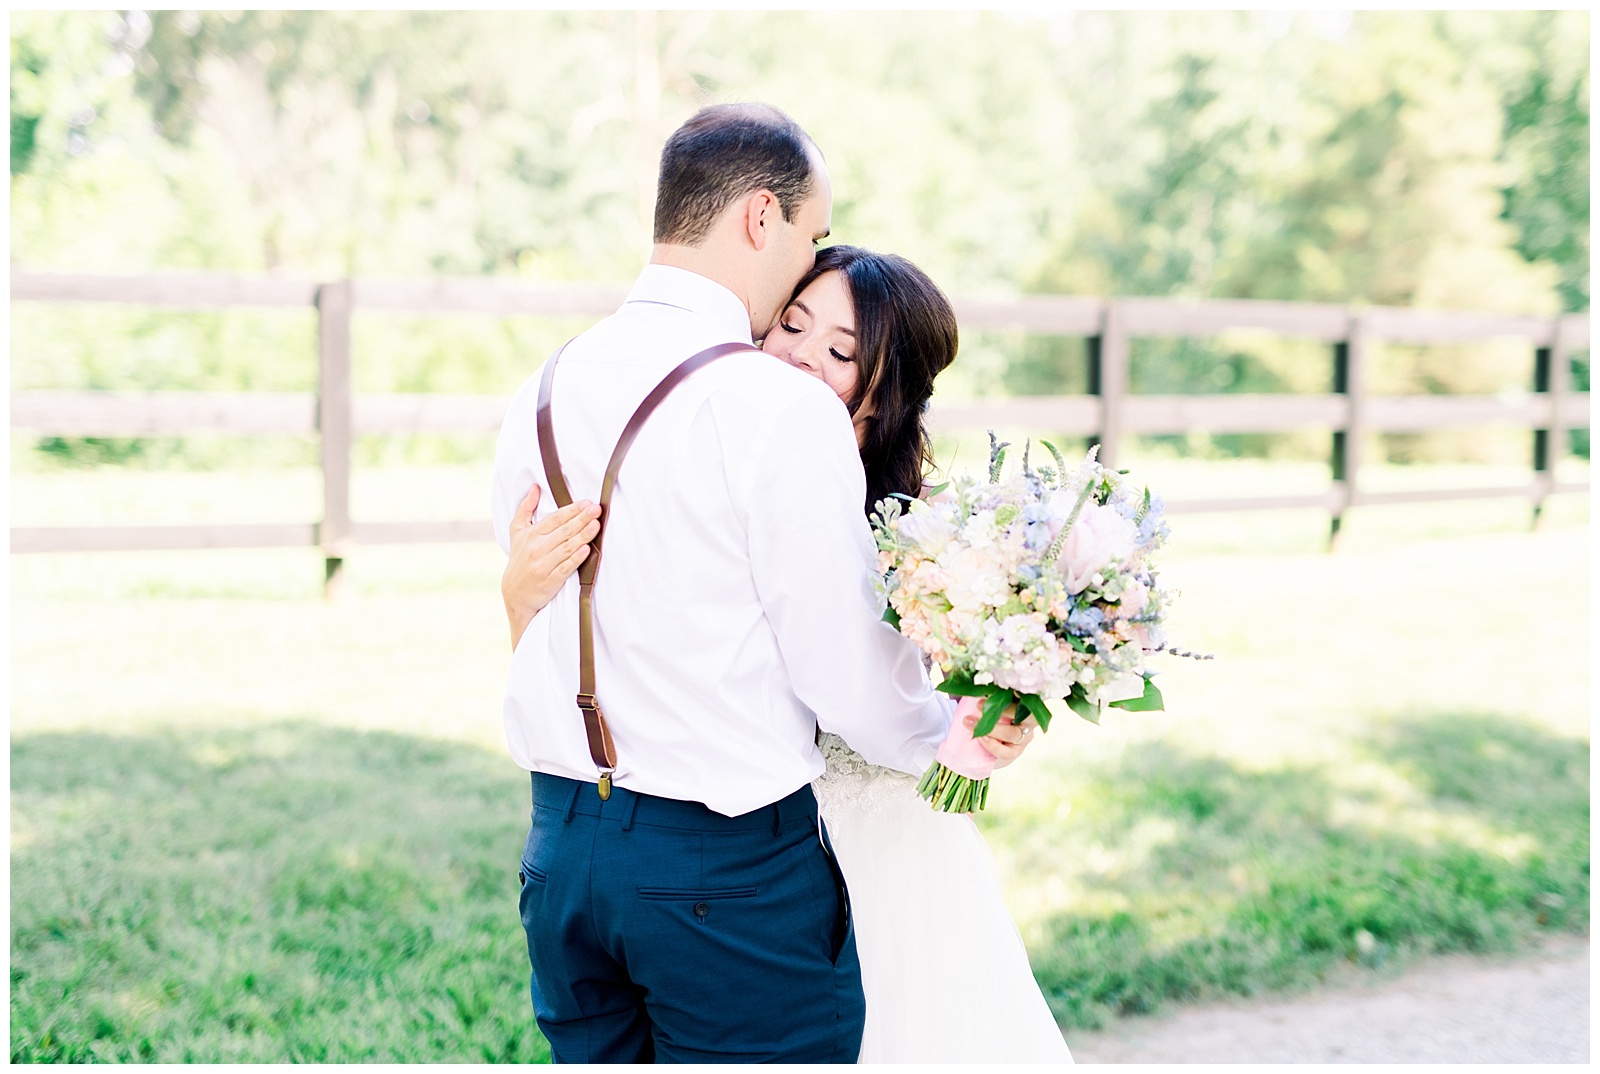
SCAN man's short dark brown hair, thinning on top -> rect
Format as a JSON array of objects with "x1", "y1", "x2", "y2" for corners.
[{"x1": 656, "y1": 104, "x2": 814, "y2": 246}]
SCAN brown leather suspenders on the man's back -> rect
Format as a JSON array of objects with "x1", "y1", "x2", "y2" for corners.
[{"x1": 538, "y1": 341, "x2": 755, "y2": 799}]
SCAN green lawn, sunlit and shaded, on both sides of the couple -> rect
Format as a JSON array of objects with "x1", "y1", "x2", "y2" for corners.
[{"x1": 10, "y1": 454, "x2": 1589, "y2": 1061}]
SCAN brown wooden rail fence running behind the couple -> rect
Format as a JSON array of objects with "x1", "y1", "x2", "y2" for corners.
[{"x1": 11, "y1": 274, "x2": 1589, "y2": 579}]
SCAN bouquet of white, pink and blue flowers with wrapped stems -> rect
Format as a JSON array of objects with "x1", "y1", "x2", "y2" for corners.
[{"x1": 872, "y1": 432, "x2": 1194, "y2": 813}]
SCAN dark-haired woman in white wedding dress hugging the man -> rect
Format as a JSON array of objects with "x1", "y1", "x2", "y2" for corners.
[{"x1": 502, "y1": 246, "x2": 1072, "y2": 1063}]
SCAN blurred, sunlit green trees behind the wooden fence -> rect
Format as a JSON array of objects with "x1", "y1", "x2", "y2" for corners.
[{"x1": 11, "y1": 11, "x2": 1589, "y2": 451}]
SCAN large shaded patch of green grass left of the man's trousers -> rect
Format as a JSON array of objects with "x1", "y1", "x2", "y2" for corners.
[{"x1": 11, "y1": 725, "x2": 549, "y2": 1063}]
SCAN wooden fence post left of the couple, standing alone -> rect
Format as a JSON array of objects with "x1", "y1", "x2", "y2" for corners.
[{"x1": 317, "y1": 280, "x2": 352, "y2": 597}]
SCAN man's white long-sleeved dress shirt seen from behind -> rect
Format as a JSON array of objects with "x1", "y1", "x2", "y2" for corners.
[{"x1": 491, "y1": 266, "x2": 954, "y2": 816}]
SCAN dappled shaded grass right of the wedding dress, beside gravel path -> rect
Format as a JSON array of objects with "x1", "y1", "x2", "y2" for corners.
[{"x1": 990, "y1": 714, "x2": 1589, "y2": 1028}]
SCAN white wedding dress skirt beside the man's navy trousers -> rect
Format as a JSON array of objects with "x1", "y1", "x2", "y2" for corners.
[{"x1": 811, "y1": 735, "x2": 1072, "y2": 1063}]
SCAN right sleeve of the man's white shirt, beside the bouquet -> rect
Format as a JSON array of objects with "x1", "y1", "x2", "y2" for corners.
[{"x1": 747, "y1": 392, "x2": 955, "y2": 775}]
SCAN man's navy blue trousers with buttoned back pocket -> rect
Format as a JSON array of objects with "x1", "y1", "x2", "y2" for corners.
[{"x1": 522, "y1": 771, "x2": 866, "y2": 1063}]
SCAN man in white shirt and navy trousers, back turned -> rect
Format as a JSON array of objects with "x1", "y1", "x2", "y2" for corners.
[{"x1": 493, "y1": 104, "x2": 1011, "y2": 1063}]
